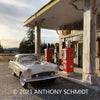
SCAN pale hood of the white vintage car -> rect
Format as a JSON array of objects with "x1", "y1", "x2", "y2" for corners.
[{"x1": 24, "y1": 62, "x2": 57, "y2": 74}]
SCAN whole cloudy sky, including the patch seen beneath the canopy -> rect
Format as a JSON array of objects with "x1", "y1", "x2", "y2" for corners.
[{"x1": 0, "y1": 0, "x2": 59, "y2": 48}]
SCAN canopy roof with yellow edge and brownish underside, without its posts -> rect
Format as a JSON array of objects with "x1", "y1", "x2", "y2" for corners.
[{"x1": 24, "y1": 0, "x2": 100, "y2": 29}]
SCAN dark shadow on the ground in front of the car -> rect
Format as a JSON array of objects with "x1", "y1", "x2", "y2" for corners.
[{"x1": 23, "y1": 78, "x2": 100, "y2": 100}]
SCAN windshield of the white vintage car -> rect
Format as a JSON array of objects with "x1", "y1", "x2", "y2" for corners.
[{"x1": 18, "y1": 55, "x2": 37, "y2": 63}]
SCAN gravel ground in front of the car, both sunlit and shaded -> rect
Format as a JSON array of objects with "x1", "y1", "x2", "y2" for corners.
[{"x1": 0, "y1": 63, "x2": 100, "y2": 100}]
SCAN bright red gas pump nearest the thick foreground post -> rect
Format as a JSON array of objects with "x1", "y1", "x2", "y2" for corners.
[{"x1": 63, "y1": 47, "x2": 74, "y2": 73}]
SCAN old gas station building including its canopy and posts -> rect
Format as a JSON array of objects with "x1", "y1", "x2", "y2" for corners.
[{"x1": 24, "y1": 0, "x2": 100, "y2": 84}]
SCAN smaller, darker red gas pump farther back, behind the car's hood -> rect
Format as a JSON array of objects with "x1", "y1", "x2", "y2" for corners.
[{"x1": 44, "y1": 45, "x2": 53, "y2": 63}]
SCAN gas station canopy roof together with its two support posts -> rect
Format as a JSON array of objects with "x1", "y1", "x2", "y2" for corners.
[{"x1": 24, "y1": 0, "x2": 100, "y2": 84}]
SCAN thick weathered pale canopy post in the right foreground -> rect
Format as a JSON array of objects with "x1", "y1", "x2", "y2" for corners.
[{"x1": 83, "y1": 0, "x2": 97, "y2": 84}]
